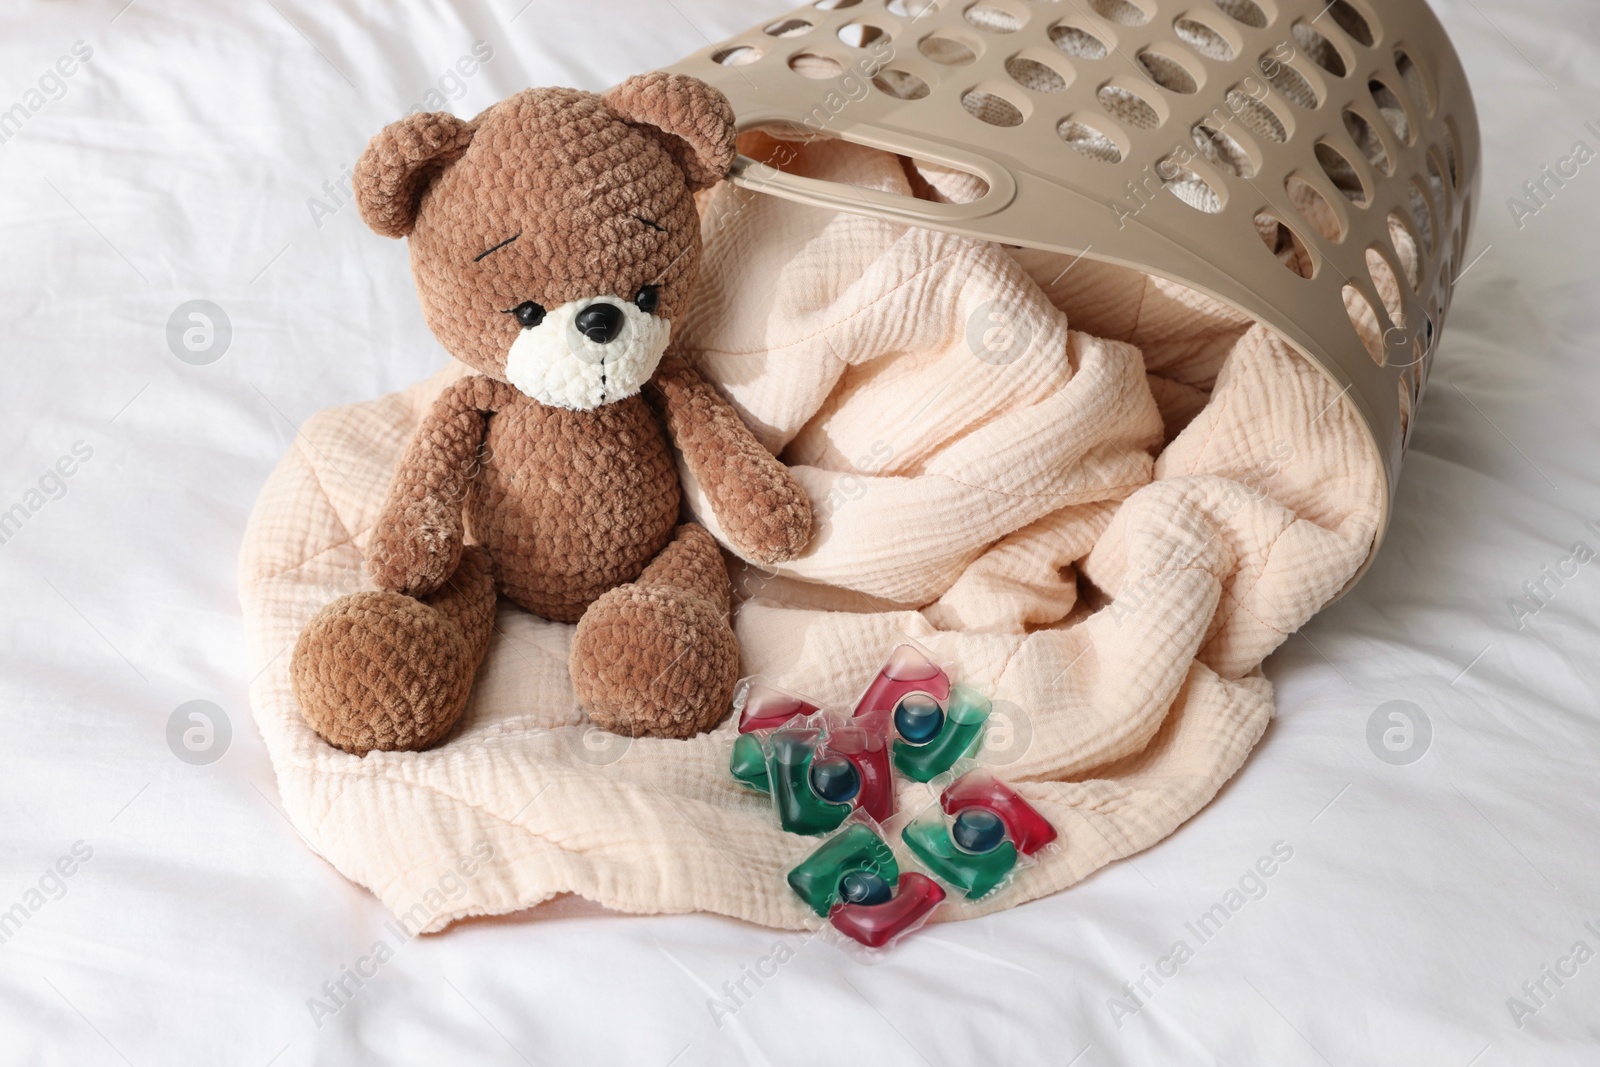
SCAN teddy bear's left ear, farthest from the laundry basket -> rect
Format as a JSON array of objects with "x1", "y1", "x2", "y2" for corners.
[{"x1": 355, "y1": 112, "x2": 474, "y2": 237}]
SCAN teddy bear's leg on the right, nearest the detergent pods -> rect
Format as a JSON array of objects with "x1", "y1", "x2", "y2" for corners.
[{"x1": 571, "y1": 523, "x2": 739, "y2": 737}]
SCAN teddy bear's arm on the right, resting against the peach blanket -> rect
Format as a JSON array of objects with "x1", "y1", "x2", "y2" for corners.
[{"x1": 650, "y1": 354, "x2": 813, "y2": 563}]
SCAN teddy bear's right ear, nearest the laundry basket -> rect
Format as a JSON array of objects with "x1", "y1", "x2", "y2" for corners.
[{"x1": 602, "y1": 70, "x2": 734, "y2": 192}]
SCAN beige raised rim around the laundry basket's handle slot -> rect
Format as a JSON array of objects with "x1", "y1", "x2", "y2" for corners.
[{"x1": 728, "y1": 115, "x2": 1016, "y2": 226}]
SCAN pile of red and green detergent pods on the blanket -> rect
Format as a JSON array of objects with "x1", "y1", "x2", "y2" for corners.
[{"x1": 730, "y1": 645, "x2": 1056, "y2": 949}]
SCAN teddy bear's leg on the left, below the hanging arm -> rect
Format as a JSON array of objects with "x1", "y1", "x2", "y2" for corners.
[{"x1": 290, "y1": 547, "x2": 494, "y2": 755}]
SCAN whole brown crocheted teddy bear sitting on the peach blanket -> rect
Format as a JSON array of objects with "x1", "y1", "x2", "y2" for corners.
[{"x1": 291, "y1": 74, "x2": 811, "y2": 753}]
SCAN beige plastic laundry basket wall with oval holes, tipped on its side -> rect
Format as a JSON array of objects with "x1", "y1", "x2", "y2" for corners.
[{"x1": 662, "y1": 0, "x2": 1480, "y2": 585}]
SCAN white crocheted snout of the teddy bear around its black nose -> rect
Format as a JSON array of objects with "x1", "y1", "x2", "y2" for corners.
[{"x1": 506, "y1": 294, "x2": 672, "y2": 411}]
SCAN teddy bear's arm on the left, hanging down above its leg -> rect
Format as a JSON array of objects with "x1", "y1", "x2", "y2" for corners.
[{"x1": 366, "y1": 374, "x2": 510, "y2": 597}]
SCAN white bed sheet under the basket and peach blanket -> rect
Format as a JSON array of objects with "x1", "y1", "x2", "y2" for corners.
[{"x1": 0, "y1": 0, "x2": 1600, "y2": 1067}]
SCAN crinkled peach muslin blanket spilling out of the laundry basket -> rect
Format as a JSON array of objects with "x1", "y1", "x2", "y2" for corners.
[{"x1": 240, "y1": 144, "x2": 1382, "y2": 929}]
